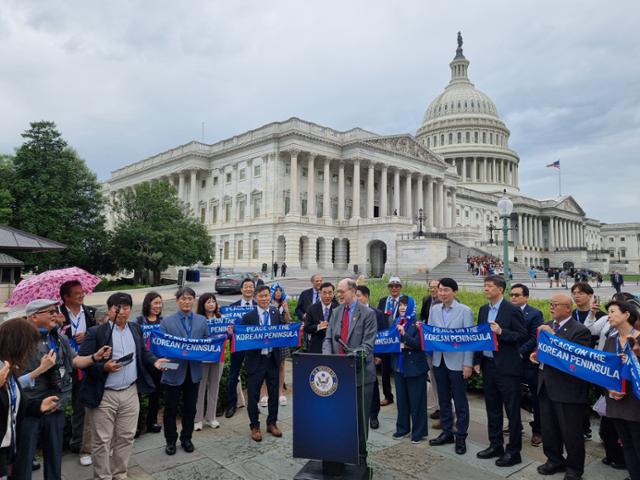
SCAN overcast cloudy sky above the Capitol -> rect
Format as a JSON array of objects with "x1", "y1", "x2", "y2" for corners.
[{"x1": 0, "y1": 0, "x2": 640, "y2": 222}]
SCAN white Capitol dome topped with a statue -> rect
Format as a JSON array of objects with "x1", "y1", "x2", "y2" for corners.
[{"x1": 416, "y1": 33, "x2": 520, "y2": 192}]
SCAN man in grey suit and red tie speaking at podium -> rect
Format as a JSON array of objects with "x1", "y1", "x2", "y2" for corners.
[{"x1": 322, "y1": 278, "x2": 377, "y2": 465}]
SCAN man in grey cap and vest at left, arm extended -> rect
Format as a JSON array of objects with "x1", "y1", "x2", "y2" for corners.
[{"x1": 13, "y1": 299, "x2": 109, "y2": 480}]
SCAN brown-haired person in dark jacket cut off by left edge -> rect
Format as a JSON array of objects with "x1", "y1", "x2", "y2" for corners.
[{"x1": 0, "y1": 318, "x2": 58, "y2": 478}]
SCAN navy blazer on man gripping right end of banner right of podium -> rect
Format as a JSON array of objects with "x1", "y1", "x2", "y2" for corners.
[{"x1": 473, "y1": 300, "x2": 527, "y2": 376}]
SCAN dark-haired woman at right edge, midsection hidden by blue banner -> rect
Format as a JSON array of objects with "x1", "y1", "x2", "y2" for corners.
[{"x1": 604, "y1": 300, "x2": 640, "y2": 480}]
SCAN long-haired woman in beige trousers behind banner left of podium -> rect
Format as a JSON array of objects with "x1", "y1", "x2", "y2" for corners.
[{"x1": 193, "y1": 293, "x2": 224, "y2": 431}]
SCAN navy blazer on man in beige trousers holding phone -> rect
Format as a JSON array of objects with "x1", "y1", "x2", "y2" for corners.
[{"x1": 78, "y1": 322, "x2": 157, "y2": 408}]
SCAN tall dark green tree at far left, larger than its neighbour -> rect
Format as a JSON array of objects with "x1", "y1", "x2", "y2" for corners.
[{"x1": 9, "y1": 121, "x2": 106, "y2": 271}]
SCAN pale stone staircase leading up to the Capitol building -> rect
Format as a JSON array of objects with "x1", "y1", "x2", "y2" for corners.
[{"x1": 410, "y1": 239, "x2": 528, "y2": 285}]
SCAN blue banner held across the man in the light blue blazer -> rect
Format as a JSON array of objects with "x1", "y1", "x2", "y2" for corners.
[{"x1": 421, "y1": 323, "x2": 498, "y2": 352}]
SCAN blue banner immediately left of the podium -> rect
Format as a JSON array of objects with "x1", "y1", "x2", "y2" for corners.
[{"x1": 231, "y1": 322, "x2": 302, "y2": 352}]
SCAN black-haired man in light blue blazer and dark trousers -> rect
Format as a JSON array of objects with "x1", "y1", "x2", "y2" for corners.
[{"x1": 429, "y1": 278, "x2": 473, "y2": 455}]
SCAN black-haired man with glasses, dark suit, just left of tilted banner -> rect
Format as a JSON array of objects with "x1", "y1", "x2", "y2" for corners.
[{"x1": 510, "y1": 283, "x2": 544, "y2": 447}]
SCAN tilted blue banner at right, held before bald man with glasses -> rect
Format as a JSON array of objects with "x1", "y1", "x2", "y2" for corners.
[{"x1": 537, "y1": 330, "x2": 623, "y2": 392}]
